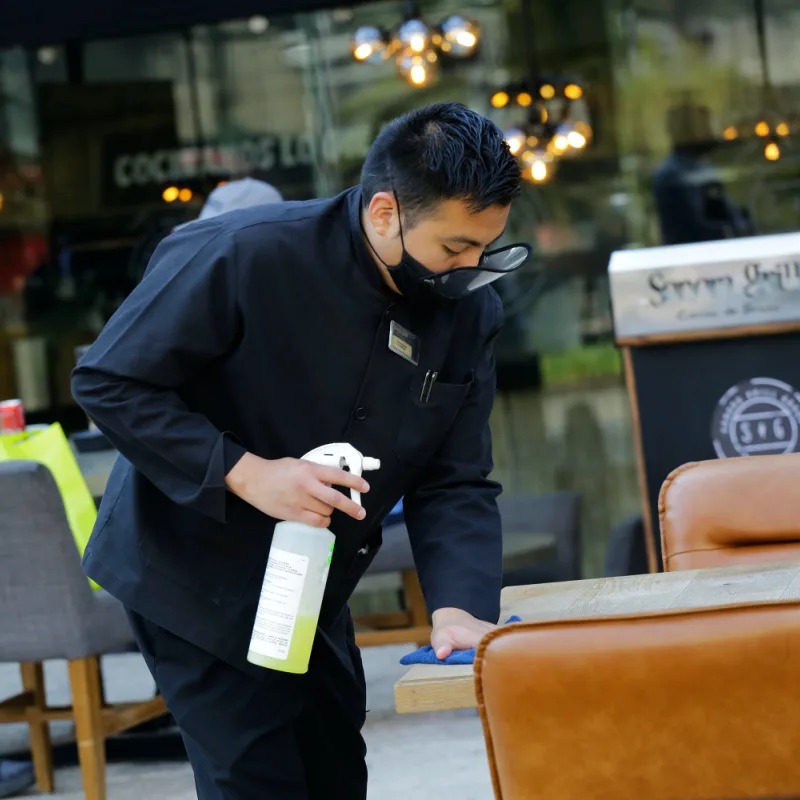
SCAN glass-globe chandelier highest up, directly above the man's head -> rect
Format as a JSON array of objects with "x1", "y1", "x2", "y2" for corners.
[{"x1": 350, "y1": 2, "x2": 480, "y2": 88}]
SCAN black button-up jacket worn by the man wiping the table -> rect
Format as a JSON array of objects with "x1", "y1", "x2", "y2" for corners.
[{"x1": 72, "y1": 189, "x2": 502, "y2": 674}]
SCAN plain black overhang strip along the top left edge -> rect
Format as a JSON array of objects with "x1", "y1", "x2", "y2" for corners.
[{"x1": 0, "y1": 0, "x2": 364, "y2": 48}]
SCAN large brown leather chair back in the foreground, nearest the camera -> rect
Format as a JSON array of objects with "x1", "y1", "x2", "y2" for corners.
[{"x1": 475, "y1": 601, "x2": 800, "y2": 800}]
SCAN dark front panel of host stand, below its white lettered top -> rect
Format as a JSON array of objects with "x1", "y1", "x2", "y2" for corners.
[{"x1": 626, "y1": 331, "x2": 800, "y2": 567}]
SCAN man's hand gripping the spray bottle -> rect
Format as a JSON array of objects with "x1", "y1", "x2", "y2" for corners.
[{"x1": 225, "y1": 453, "x2": 369, "y2": 528}]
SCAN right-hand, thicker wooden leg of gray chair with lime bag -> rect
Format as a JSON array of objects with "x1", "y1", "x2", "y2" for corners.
[{"x1": 69, "y1": 658, "x2": 106, "y2": 800}]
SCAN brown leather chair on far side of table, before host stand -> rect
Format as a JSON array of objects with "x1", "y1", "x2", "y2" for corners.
[{"x1": 658, "y1": 454, "x2": 800, "y2": 572}]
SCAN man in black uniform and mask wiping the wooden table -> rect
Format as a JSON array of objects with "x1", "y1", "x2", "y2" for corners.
[{"x1": 73, "y1": 104, "x2": 527, "y2": 800}]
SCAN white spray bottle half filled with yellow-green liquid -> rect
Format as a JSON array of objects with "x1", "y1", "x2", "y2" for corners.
[{"x1": 247, "y1": 444, "x2": 381, "y2": 674}]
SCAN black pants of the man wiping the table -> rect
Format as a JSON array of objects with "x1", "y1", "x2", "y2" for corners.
[{"x1": 128, "y1": 610, "x2": 367, "y2": 800}]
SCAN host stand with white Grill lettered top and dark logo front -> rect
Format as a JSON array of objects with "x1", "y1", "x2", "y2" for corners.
[{"x1": 609, "y1": 234, "x2": 800, "y2": 571}]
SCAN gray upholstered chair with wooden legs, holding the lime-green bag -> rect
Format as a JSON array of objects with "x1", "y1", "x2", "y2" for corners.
[{"x1": 0, "y1": 461, "x2": 166, "y2": 800}]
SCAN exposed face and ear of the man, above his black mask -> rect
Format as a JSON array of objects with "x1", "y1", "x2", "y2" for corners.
[{"x1": 368, "y1": 192, "x2": 510, "y2": 272}]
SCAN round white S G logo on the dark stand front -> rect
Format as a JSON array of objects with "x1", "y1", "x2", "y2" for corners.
[{"x1": 711, "y1": 378, "x2": 800, "y2": 458}]
